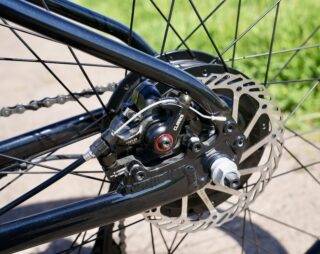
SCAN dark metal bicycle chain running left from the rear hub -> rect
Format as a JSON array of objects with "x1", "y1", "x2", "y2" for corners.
[{"x1": 0, "y1": 83, "x2": 117, "y2": 117}]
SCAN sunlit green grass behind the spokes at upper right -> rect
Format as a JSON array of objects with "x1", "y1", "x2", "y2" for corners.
[{"x1": 77, "y1": 0, "x2": 320, "y2": 130}]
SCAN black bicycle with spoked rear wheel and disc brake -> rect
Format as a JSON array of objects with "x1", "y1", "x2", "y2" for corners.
[{"x1": 0, "y1": 0, "x2": 319, "y2": 253}]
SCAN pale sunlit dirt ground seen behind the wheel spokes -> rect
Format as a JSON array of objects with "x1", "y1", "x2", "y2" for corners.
[{"x1": 0, "y1": 23, "x2": 320, "y2": 254}]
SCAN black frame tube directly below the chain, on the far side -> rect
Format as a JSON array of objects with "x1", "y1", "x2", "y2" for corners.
[{"x1": 0, "y1": 109, "x2": 104, "y2": 170}]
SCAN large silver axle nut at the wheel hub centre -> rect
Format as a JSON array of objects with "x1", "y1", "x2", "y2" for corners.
[{"x1": 210, "y1": 157, "x2": 240, "y2": 189}]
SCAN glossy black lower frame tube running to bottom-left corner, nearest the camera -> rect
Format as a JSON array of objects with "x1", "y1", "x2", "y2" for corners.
[{"x1": 0, "y1": 172, "x2": 194, "y2": 254}]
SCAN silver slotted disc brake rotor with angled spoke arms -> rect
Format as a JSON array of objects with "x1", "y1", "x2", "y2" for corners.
[{"x1": 144, "y1": 57, "x2": 283, "y2": 232}]
